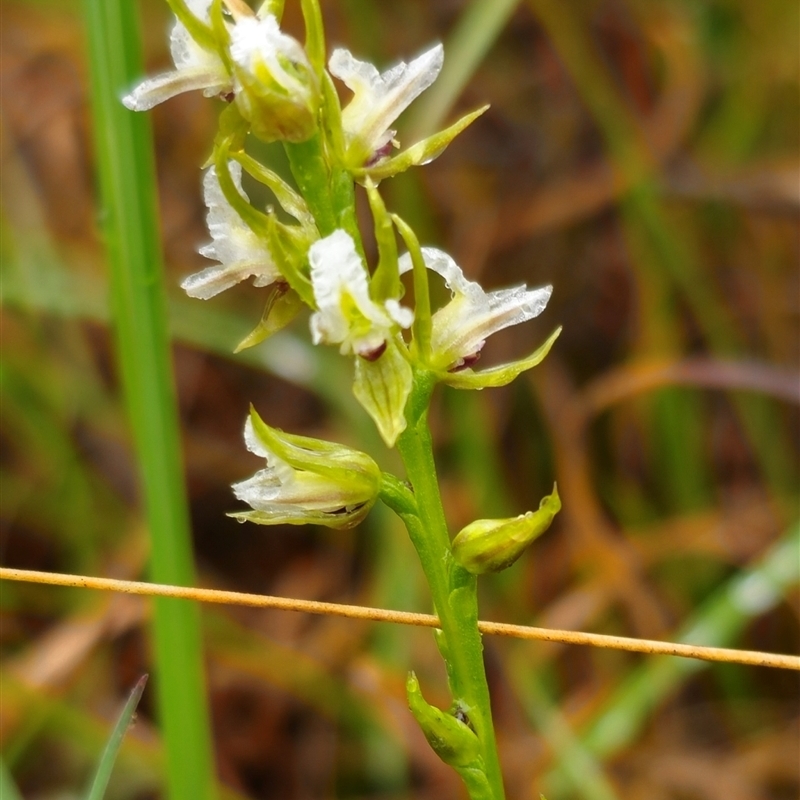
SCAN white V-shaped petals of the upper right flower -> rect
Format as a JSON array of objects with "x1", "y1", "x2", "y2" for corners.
[{"x1": 328, "y1": 44, "x2": 444, "y2": 167}]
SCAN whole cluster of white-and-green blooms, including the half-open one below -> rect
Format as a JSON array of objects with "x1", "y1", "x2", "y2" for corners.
[{"x1": 123, "y1": 0, "x2": 558, "y2": 526}]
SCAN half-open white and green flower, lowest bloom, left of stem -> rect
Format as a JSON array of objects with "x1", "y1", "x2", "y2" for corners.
[{"x1": 230, "y1": 409, "x2": 381, "y2": 528}]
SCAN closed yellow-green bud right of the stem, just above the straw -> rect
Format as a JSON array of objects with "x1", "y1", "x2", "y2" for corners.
[{"x1": 453, "y1": 484, "x2": 561, "y2": 575}]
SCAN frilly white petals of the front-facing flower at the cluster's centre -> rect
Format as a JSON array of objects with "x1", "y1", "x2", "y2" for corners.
[{"x1": 308, "y1": 229, "x2": 414, "y2": 360}]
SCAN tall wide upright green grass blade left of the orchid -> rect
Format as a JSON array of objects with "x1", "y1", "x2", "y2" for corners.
[{"x1": 85, "y1": 0, "x2": 214, "y2": 800}]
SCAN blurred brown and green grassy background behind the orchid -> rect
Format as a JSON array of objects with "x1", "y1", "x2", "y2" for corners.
[{"x1": 0, "y1": 0, "x2": 800, "y2": 800}]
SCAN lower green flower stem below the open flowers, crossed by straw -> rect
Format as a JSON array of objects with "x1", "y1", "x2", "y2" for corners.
[{"x1": 397, "y1": 370, "x2": 505, "y2": 800}]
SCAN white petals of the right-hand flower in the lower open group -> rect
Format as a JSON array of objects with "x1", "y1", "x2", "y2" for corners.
[{"x1": 399, "y1": 247, "x2": 553, "y2": 373}]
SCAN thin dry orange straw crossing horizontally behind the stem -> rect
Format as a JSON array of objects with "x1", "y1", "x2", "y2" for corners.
[{"x1": 0, "y1": 567, "x2": 800, "y2": 671}]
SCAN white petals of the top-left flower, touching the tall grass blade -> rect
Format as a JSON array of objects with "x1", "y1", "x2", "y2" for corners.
[{"x1": 122, "y1": 0, "x2": 233, "y2": 111}]
